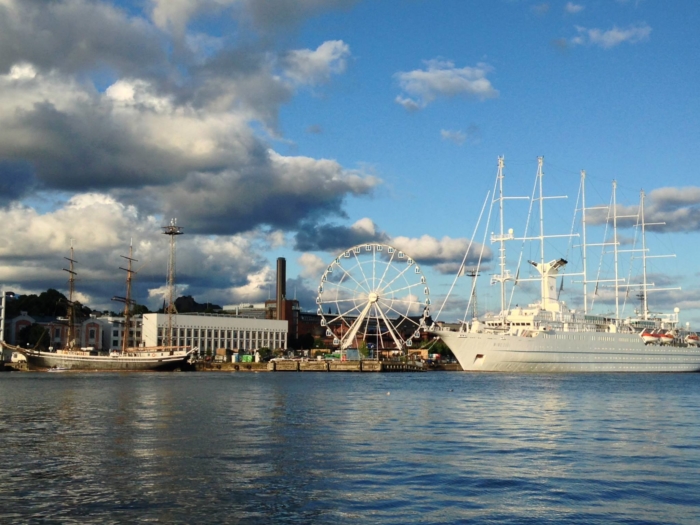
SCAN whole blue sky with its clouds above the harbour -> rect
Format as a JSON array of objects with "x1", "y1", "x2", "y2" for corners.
[{"x1": 0, "y1": 0, "x2": 700, "y2": 329}]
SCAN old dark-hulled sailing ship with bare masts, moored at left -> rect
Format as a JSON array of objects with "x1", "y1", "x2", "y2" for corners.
[{"x1": 3, "y1": 220, "x2": 197, "y2": 371}]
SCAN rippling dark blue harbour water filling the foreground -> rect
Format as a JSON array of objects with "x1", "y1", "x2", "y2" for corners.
[{"x1": 0, "y1": 372, "x2": 700, "y2": 525}]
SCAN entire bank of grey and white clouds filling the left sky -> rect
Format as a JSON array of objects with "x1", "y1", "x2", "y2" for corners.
[{"x1": 0, "y1": 0, "x2": 372, "y2": 309}]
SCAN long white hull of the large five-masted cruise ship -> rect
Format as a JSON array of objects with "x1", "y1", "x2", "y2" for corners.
[{"x1": 432, "y1": 330, "x2": 700, "y2": 373}]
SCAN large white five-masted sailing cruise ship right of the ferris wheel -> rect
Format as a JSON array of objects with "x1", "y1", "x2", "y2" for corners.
[{"x1": 429, "y1": 157, "x2": 700, "y2": 373}]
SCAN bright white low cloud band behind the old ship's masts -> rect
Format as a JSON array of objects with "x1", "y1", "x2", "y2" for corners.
[{"x1": 0, "y1": 193, "x2": 274, "y2": 310}]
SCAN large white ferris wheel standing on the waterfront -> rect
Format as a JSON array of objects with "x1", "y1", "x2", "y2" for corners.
[{"x1": 316, "y1": 244, "x2": 430, "y2": 352}]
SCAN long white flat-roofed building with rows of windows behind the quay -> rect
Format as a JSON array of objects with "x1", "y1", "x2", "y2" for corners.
[{"x1": 142, "y1": 314, "x2": 288, "y2": 353}]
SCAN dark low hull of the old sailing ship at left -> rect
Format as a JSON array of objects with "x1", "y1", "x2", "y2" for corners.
[{"x1": 8, "y1": 350, "x2": 192, "y2": 371}]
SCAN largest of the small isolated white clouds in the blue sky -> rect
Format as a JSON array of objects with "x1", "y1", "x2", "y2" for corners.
[{"x1": 395, "y1": 59, "x2": 498, "y2": 110}]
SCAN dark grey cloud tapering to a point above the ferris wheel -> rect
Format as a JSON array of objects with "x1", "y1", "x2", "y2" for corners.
[{"x1": 120, "y1": 152, "x2": 380, "y2": 234}]
